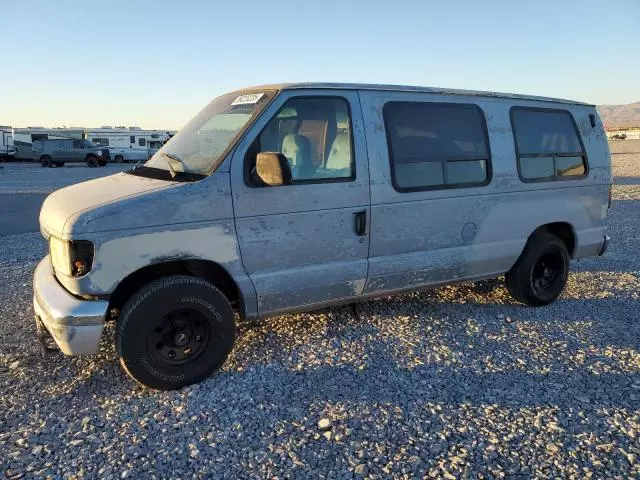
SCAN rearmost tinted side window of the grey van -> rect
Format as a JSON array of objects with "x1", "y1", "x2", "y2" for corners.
[{"x1": 511, "y1": 107, "x2": 587, "y2": 182}]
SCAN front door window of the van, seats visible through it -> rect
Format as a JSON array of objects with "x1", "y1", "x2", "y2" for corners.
[{"x1": 247, "y1": 97, "x2": 355, "y2": 186}]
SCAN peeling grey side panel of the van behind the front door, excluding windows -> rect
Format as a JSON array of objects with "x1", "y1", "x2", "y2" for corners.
[{"x1": 360, "y1": 91, "x2": 611, "y2": 294}]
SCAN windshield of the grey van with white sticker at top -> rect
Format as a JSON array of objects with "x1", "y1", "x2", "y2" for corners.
[{"x1": 145, "y1": 91, "x2": 273, "y2": 175}]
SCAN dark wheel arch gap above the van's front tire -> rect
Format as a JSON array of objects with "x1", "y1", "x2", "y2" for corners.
[{"x1": 109, "y1": 259, "x2": 245, "y2": 317}]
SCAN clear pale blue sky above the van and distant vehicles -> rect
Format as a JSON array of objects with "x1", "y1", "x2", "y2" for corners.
[{"x1": 0, "y1": 0, "x2": 640, "y2": 129}]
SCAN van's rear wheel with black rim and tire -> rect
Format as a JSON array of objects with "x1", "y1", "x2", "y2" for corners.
[{"x1": 505, "y1": 233, "x2": 570, "y2": 307}]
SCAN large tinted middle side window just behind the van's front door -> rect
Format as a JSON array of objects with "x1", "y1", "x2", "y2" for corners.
[{"x1": 383, "y1": 102, "x2": 491, "y2": 192}]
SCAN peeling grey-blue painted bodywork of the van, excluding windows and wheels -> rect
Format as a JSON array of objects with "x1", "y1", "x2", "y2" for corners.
[{"x1": 35, "y1": 84, "x2": 612, "y2": 326}]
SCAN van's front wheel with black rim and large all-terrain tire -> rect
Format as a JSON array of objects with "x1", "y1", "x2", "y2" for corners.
[{"x1": 116, "y1": 276, "x2": 235, "y2": 390}]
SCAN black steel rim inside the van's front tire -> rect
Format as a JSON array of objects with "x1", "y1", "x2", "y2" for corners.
[{"x1": 147, "y1": 307, "x2": 213, "y2": 365}]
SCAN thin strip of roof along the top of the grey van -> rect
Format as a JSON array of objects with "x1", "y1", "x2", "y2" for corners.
[{"x1": 240, "y1": 82, "x2": 595, "y2": 107}]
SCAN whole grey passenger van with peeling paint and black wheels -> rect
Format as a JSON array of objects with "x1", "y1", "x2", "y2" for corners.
[{"x1": 34, "y1": 84, "x2": 611, "y2": 389}]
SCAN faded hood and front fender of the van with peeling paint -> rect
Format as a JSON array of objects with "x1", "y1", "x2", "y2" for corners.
[{"x1": 40, "y1": 171, "x2": 257, "y2": 316}]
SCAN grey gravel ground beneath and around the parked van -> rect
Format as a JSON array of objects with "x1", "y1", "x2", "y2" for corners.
[{"x1": 0, "y1": 142, "x2": 640, "y2": 479}]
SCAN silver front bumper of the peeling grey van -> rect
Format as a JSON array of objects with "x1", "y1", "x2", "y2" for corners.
[{"x1": 33, "y1": 255, "x2": 109, "y2": 355}]
